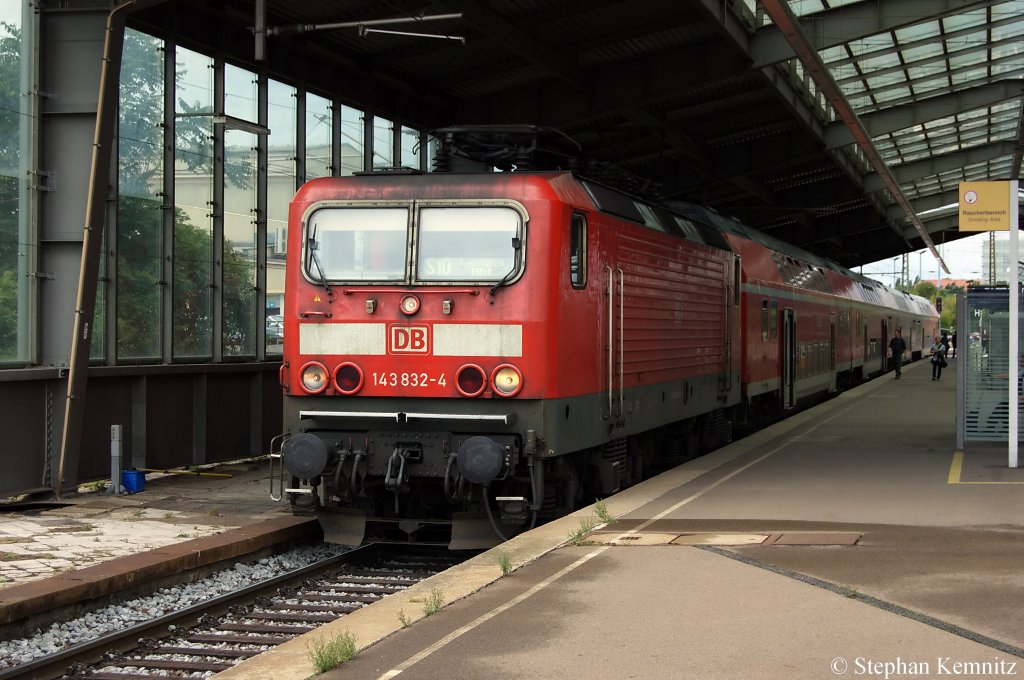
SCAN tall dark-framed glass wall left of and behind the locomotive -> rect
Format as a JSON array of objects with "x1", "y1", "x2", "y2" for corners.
[{"x1": 0, "y1": 17, "x2": 420, "y2": 366}]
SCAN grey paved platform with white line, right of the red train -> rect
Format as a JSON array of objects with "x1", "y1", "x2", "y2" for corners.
[{"x1": 218, "y1": 362, "x2": 1024, "y2": 680}]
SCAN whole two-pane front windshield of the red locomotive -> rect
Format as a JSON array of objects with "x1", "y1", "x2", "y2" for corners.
[{"x1": 305, "y1": 206, "x2": 522, "y2": 284}]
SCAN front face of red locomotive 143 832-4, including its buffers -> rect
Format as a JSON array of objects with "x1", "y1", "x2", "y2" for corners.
[{"x1": 275, "y1": 176, "x2": 544, "y2": 547}]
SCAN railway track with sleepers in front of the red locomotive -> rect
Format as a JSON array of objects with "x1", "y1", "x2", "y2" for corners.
[{"x1": 0, "y1": 545, "x2": 468, "y2": 680}]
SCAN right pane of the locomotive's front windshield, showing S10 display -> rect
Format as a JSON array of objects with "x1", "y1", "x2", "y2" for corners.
[{"x1": 416, "y1": 206, "x2": 522, "y2": 283}]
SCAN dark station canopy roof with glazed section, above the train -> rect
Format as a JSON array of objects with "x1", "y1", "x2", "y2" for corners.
[{"x1": 129, "y1": 0, "x2": 1024, "y2": 267}]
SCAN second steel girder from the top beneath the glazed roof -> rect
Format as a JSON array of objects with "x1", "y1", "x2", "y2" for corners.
[{"x1": 824, "y1": 80, "x2": 1024, "y2": 148}]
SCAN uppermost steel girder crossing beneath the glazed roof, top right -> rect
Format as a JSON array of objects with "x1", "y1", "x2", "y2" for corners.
[{"x1": 750, "y1": 0, "x2": 1004, "y2": 68}]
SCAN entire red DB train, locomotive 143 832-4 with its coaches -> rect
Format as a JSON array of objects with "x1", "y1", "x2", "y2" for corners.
[{"x1": 272, "y1": 130, "x2": 937, "y2": 548}]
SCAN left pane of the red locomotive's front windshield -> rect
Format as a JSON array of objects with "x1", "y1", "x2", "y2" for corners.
[{"x1": 304, "y1": 208, "x2": 409, "y2": 281}]
